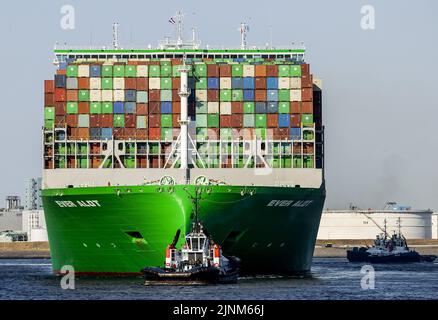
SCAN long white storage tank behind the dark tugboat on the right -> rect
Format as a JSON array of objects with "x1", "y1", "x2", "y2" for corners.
[{"x1": 318, "y1": 203, "x2": 434, "y2": 240}]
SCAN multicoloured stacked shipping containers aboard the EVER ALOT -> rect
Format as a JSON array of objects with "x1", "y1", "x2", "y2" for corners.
[{"x1": 44, "y1": 58, "x2": 315, "y2": 168}]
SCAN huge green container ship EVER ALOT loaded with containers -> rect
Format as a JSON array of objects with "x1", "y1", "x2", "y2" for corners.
[{"x1": 42, "y1": 15, "x2": 325, "y2": 275}]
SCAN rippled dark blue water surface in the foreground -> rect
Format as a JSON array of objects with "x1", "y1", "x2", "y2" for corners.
[{"x1": 0, "y1": 258, "x2": 438, "y2": 300}]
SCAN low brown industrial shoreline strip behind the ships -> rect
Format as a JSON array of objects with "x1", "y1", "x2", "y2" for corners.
[{"x1": 0, "y1": 239, "x2": 438, "y2": 259}]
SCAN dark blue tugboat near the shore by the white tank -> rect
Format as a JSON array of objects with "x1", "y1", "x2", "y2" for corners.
[{"x1": 347, "y1": 218, "x2": 437, "y2": 263}]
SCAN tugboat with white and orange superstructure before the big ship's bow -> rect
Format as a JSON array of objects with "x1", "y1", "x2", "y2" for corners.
[{"x1": 142, "y1": 189, "x2": 240, "y2": 285}]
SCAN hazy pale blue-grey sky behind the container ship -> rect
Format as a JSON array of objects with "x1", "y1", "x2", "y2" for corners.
[{"x1": 0, "y1": 0, "x2": 438, "y2": 209}]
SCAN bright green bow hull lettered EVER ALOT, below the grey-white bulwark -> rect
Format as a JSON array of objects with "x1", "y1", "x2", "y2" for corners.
[{"x1": 42, "y1": 185, "x2": 325, "y2": 274}]
